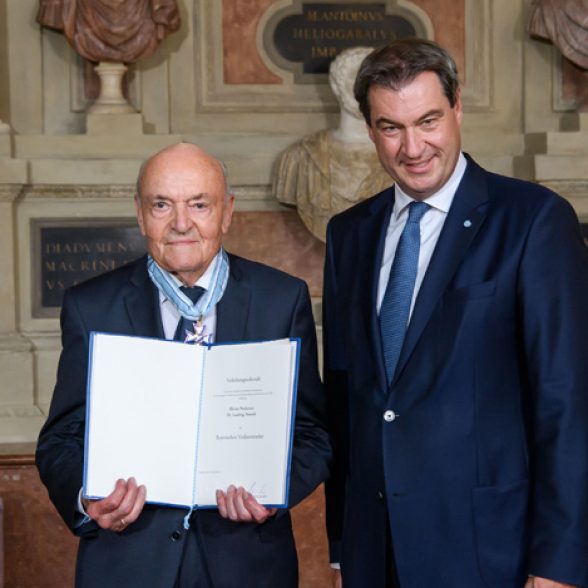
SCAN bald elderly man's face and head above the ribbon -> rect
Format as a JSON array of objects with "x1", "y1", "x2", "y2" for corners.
[{"x1": 135, "y1": 144, "x2": 233, "y2": 286}]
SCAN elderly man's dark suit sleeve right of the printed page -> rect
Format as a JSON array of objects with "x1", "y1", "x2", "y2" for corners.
[{"x1": 289, "y1": 285, "x2": 331, "y2": 507}]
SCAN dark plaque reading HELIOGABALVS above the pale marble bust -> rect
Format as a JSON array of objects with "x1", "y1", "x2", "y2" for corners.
[{"x1": 264, "y1": 2, "x2": 424, "y2": 83}]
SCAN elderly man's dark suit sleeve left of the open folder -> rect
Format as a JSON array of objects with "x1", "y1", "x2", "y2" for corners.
[{"x1": 36, "y1": 292, "x2": 88, "y2": 529}]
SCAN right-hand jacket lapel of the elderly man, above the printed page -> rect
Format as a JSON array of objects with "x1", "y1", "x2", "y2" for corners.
[{"x1": 215, "y1": 255, "x2": 251, "y2": 342}]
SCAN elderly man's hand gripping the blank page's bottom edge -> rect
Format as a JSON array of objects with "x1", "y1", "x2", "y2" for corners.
[{"x1": 83, "y1": 478, "x2": 146, "y2": 533}]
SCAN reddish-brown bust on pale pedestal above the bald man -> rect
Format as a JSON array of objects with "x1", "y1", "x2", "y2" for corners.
[{"x1": 37, "y1": 0, "x2": 181, "y2": 114}]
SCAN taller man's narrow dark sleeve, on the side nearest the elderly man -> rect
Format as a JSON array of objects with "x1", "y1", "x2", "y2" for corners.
[{"x1": 323, "y1": 218, "x2": 349, "y2": 563}]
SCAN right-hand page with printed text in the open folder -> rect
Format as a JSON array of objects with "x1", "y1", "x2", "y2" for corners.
[{"x1": 196, "y1": 339, "x2": 297, "y2": 506}]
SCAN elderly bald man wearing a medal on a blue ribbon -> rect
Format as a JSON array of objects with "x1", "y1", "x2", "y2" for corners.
[{"x1": 37, "y1": 144, "x2": 330, "y2": 588}]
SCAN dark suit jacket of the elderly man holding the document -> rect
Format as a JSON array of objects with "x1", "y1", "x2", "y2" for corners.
[{"x1": 37, "y1": 256, "x2": 330, "y2": 588}]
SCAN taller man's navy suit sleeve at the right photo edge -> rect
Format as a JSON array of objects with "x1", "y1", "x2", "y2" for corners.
[{"x1": 519, "y1": 198, "x2": 588, "y2": 586}]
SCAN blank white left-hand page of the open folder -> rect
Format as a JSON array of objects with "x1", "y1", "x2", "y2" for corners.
[{"x1": 84, "y1": 333, "x2": 205, "y2": 506}]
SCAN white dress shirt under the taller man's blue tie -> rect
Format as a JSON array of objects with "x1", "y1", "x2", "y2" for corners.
[{"x1": 376, "y1": 153, "x2": 467, "y2": 318}]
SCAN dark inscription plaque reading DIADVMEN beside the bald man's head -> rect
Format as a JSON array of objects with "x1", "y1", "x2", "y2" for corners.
[{"x1": 31, "y1": 219, "x2": 145, "y2": 318}]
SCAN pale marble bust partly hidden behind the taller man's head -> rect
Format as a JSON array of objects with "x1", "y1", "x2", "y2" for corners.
[{"x1": 273, "y1": 47, "x2": 392, "y2": 241}]
